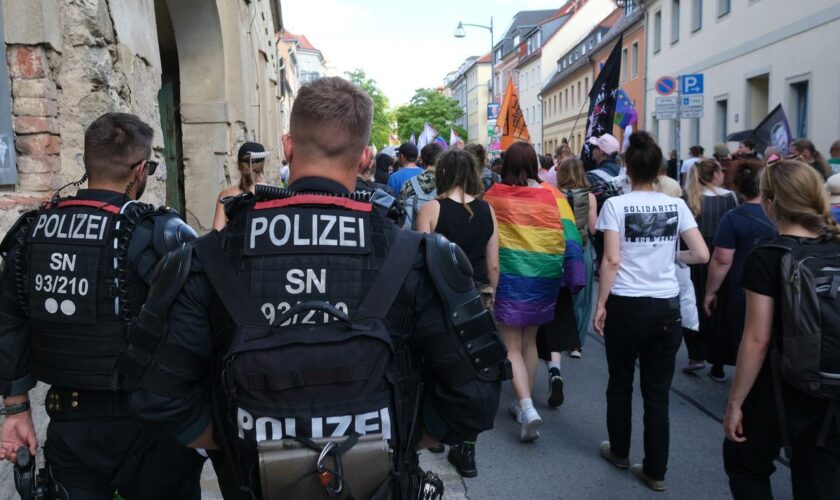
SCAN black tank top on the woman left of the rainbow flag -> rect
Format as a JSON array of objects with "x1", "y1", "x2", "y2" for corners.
[{"x1": 435, "y1": 198, "x2": 493, "y2": 283}]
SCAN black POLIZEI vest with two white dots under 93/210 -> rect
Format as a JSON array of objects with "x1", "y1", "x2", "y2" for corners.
[{"x1": 18, "y1": 198, "x2": 145, "y2": 390}]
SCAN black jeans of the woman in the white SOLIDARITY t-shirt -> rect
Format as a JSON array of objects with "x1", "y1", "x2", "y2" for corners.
[{"x1": 604, "y1": 295, "x2": 682, "y2": 480}]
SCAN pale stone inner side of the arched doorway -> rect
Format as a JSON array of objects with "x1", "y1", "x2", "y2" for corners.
[{"x1": 158, "y1": 0, "x2": 229, "y2": 231}]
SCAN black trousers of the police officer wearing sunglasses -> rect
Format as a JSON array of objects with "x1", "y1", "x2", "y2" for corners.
[{"x1": 44, "y1": 418, "x2": 204, "y2": 500}]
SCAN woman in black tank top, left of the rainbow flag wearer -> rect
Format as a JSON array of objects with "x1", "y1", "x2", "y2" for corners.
[{"x1": 417, "y1": 149, "x2": 499, "y2": 477}]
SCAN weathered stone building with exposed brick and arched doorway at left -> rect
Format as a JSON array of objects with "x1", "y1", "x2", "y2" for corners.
[{"x1": 0, "y1": 0, "x2": 282, "y2": 234}]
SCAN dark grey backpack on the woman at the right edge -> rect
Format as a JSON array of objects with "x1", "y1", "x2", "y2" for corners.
[{"x1": 760, "y1": 236, "x2": 840, "y2": 401}]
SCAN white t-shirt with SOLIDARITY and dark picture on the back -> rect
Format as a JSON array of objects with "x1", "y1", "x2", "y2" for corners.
[{"x1": 596, "y1": 191, "x2": 697, "y2": 299}]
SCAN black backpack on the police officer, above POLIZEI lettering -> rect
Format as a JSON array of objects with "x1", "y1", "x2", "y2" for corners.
[{"x1": 194, "y1": 230, "x2": 422, "y2": 498}]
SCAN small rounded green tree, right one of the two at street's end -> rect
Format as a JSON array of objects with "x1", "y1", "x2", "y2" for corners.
[{"x1": 394, "y1": 89, "x2": 467, "y2": 142}]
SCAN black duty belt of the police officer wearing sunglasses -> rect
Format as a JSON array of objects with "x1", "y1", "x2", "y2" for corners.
[{"x1": 45, "y1": 387, "x2": 134, "y2": 422}]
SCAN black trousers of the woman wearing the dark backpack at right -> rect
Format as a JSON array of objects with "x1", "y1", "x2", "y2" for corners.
[{"x1": 723, "y1": 363, "x2": 840, "y2": 500}]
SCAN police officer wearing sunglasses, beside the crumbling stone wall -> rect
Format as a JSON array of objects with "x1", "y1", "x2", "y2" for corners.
[{"x1": 0, "y1": 113, "x2": 203, "y2": 500}]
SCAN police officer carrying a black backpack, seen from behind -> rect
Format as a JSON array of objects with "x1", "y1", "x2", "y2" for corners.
[{"x1": 132, "y1": 78, "x2": 502, "y2": 499}]
